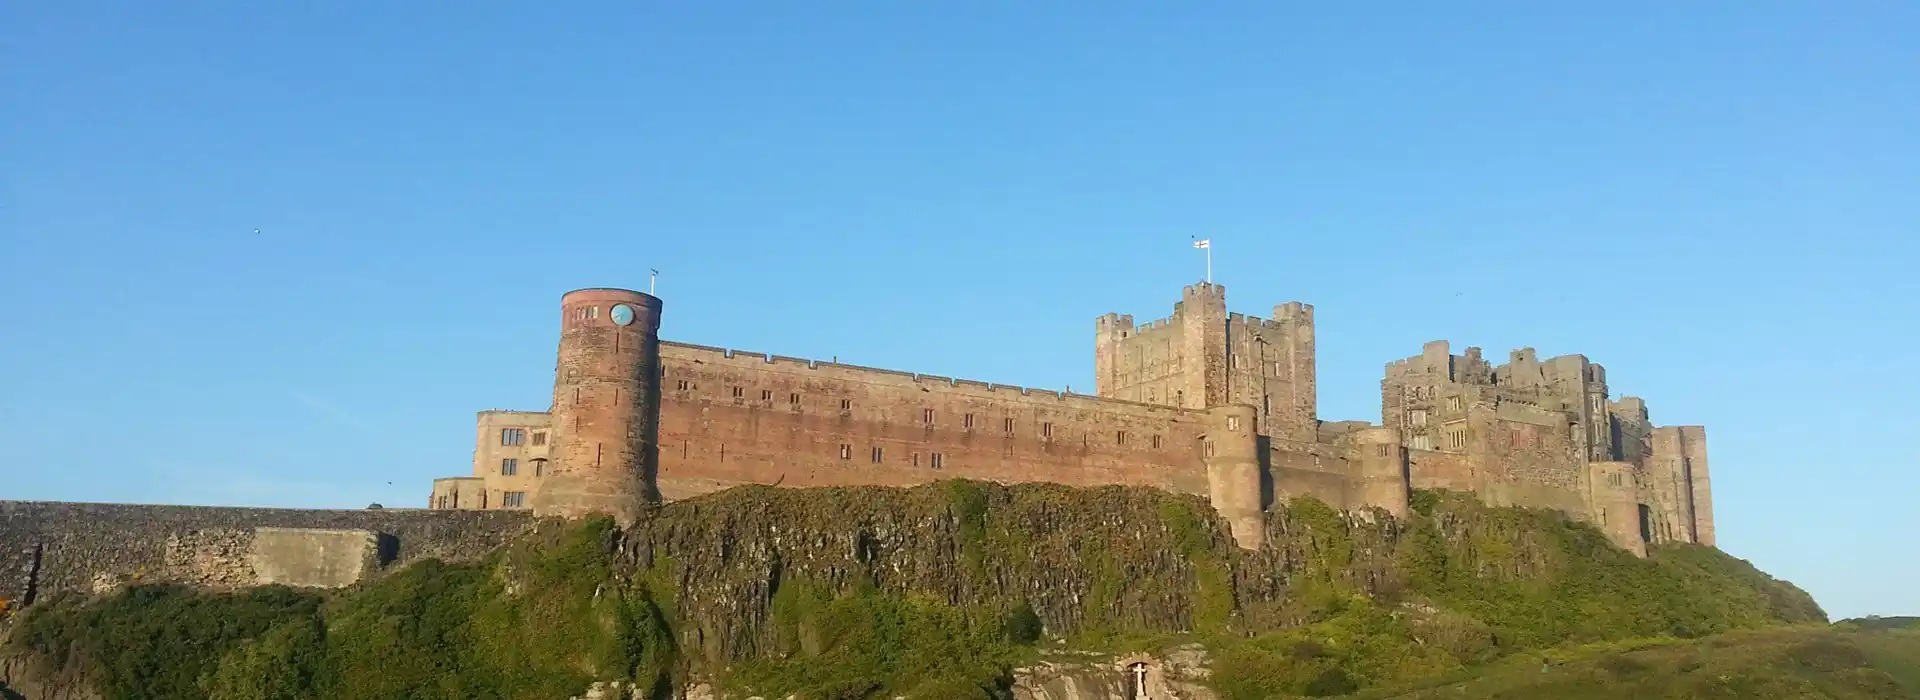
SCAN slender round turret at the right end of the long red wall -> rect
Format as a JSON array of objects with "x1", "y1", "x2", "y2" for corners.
[{"x1": 1202, "y1": 405, "x2": 1267, "y2": 548}]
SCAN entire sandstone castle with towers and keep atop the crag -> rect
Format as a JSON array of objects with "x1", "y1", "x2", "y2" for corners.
[{"x1": 430, "y1": 282, "x2": 1713, "y2": 554}]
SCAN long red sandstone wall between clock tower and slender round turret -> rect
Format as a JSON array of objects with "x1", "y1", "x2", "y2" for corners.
[{"x1": 659, "y1": 341, "x2": 1208, "y2": 499}]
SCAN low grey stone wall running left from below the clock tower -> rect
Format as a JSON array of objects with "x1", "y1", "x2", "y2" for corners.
[{"x1": 0, "y1": 501, "x2": 532, "y2": 604}]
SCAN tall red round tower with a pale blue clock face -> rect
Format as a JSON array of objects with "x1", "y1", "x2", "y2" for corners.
[{"x1": 534, "y1": 288, "x2": 660, "y2": 525}]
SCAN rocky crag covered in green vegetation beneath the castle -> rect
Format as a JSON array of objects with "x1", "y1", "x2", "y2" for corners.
[{"x1": 10, "y1": 481, "x2": 1843, "y2": 700}]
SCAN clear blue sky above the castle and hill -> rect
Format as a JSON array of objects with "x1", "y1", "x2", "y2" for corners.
[{"x1": 0, "y1": 0, "x2": 1920, "y2": 616}]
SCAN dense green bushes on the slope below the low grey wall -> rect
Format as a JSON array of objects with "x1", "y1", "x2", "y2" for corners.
[{"x1": 13, "y1": 520, "x2": 674, "y2": 700}]
